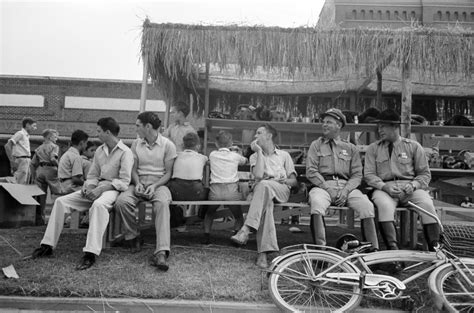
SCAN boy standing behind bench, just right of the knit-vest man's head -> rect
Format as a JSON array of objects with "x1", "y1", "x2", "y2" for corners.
[{"x1": 163, "y1": 101, "x2": 197, "y2": 152}]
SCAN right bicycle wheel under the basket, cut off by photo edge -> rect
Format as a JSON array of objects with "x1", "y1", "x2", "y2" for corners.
[{"x1": 429, "y1": 259, "x2": 474, "y2": 313}]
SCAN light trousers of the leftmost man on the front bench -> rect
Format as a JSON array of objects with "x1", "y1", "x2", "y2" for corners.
[{"x1": 41, "y1": 190, "x2": 119, "y2": 255}]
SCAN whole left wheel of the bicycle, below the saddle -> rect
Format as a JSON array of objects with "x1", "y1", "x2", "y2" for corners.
[{"x1": 268, "y1": 252, "x2": 362, "y2": 312}]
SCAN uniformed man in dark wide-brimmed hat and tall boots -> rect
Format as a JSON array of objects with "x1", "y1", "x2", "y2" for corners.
[{"x1": 364, "y1": 109, "x2": 440, "y2": 251}]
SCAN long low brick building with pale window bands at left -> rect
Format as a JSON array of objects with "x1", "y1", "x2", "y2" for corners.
[{"x1": 0, "y1": 75, "x2": 165, "y2": 138}]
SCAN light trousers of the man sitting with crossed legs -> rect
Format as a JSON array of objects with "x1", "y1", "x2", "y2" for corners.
[{"x1": 245, "y1": 180, "x2": 290, "y2": 253}]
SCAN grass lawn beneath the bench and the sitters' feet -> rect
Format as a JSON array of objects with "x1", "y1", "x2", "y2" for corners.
[{"x1": 0, "y1": 221, "x2": 432, "y2": 312}]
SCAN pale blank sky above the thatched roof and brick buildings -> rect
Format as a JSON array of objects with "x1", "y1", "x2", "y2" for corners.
[{"x1": 0, "y1": 0, "x2": 324, "y2": 80}]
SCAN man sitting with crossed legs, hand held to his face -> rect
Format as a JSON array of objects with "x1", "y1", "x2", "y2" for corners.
[{"x1": 231, "y1": 124, "x2": 297, "y2": 268}]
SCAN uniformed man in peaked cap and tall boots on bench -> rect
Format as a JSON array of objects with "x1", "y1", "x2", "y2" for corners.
[{"x1": 306, "y1": 108, "x2": 379, "y2": 249}]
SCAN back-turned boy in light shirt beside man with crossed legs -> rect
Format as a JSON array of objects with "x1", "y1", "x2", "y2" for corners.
[{"x1": 204, "y1": 130, "x2": 247, "y2": 244}]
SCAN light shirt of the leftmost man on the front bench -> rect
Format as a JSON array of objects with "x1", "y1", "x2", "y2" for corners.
[{"x1": 84, "y1": 140, "x2": 133, "y2": 191}]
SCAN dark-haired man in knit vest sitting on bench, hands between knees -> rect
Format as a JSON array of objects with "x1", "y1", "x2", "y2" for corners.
[{"x1": 115, "y1": 112, "x2": 176, "y2": 271}]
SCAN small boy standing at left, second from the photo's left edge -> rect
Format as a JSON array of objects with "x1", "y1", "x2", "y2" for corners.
[{"x1": 31, "y1": 129, "x2": 61, "y2": 225}]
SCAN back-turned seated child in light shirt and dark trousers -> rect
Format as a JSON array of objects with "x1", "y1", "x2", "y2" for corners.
[{"x1": 168, "y1": 133, "x2": 208, "y2": 201}]
